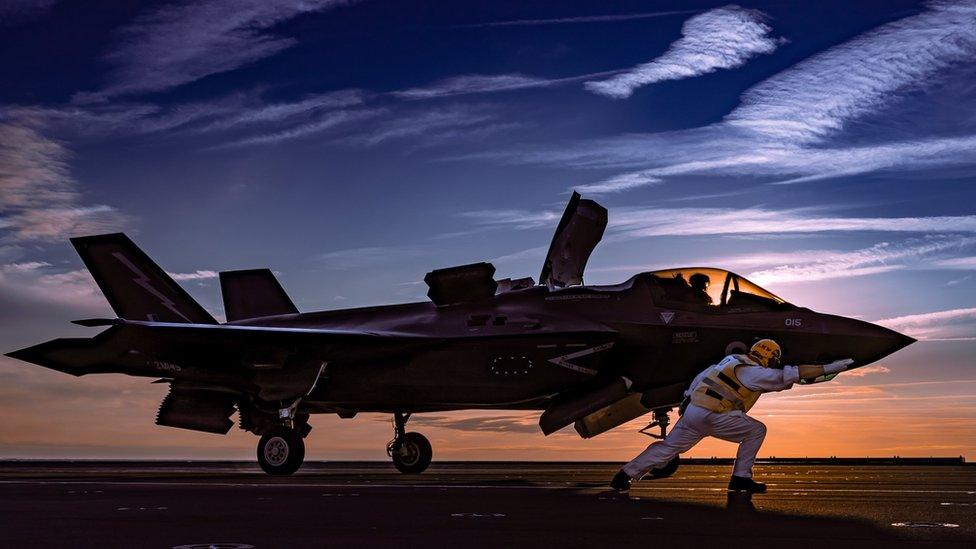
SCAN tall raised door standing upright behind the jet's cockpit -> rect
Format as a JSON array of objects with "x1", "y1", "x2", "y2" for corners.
[{"x1": 539, "y1": 192, "x2": 607, "y2": 288}]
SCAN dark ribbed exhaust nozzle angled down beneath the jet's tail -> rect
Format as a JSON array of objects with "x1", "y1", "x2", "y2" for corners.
[{"x1": 156, "y1": 387, "x2": 237, "y2": 435}]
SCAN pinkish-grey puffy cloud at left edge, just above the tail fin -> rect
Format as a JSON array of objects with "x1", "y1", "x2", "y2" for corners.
[{"x1": 0, "y1": 115, "x2": 126, "y2": 241}]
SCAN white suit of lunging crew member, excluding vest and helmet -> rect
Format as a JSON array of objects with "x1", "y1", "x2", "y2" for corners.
[{"x1": 623, "y1": 358, "x2": 800, "y2": 479}]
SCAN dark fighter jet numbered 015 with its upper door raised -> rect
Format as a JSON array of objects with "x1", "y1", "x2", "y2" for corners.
[{"x1": 9, "y1": 193, "x2": 915, "y2": 475}]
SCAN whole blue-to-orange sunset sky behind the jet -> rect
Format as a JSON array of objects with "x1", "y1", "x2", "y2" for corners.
[{"x1": 0, "y1": 0, "x2": 976, "y2": 461}]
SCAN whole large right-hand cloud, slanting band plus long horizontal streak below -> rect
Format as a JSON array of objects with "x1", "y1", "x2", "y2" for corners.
[{"x1": 496, "y1": 1, "x2": 976, "y2": 194}]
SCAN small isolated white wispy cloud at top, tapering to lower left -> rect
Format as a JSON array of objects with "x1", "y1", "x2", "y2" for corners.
[{"x1": 586, "y1": 5, "x2": 780, "y2": 99}]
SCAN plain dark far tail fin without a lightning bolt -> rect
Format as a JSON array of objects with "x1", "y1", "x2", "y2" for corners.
[{"x1": 220, "y1": 269, "x2": 298, "y2": 322}]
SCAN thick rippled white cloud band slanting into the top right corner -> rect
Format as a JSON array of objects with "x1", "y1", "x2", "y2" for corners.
[{"x1": 726, "y1": 2, "x2": 976, "y2": 143}]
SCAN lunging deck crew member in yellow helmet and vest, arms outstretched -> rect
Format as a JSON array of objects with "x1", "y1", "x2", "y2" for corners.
[{"x1": 610, "y1": 339, "x2": 854, "y2": 493}]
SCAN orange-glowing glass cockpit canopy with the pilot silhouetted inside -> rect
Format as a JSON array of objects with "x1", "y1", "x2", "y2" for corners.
[{"x1": 649, "y1": 267, "x2": 792, "y2": 312}]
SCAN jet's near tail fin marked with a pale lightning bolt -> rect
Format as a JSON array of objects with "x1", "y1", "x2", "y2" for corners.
[{"x1": 71, "y1": 233, "x2": 217, "y2": 324}]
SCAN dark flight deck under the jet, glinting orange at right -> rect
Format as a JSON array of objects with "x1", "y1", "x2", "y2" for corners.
[{"x1": 0, "y1": 461, "x2": 976, "y2": 549}]
